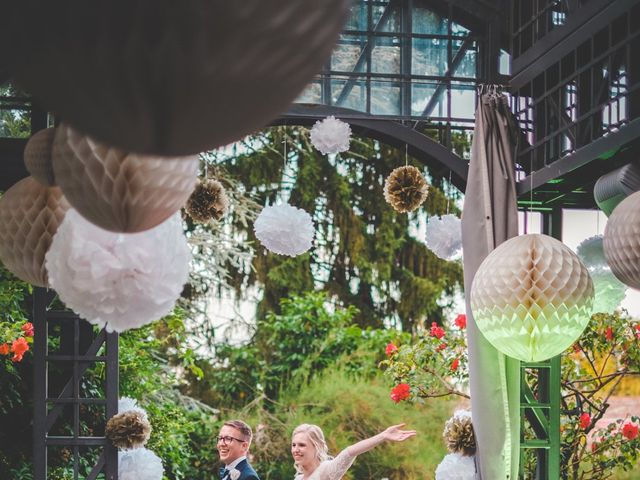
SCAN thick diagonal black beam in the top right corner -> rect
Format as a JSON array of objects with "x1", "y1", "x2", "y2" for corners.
[{"x1": 511, "y1": 0, "x2": 640, "y2": 91}]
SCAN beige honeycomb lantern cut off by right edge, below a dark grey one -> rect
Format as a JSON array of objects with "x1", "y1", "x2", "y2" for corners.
[{"x1": 603, "y1": 192, "x2": 640, "y2": 290}]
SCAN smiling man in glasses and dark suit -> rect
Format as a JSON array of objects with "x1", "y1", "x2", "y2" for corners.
[{"x1": 217, "y1": 420, "x2": 260, "y2": 480}]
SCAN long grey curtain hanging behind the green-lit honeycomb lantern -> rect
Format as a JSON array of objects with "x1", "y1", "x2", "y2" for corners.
[{"x1": 462, "y1": 85, "x2": 520, "y2": 480}]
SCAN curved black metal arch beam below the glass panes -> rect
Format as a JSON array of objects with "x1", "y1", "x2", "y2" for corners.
[{"x1": 273, "y1": 104, "x2": 469, "y2": 191}]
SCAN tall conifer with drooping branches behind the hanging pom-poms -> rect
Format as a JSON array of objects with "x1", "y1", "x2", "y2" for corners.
[{"x1": 215, "y1": 127, "x2": 462, "y2": 331}]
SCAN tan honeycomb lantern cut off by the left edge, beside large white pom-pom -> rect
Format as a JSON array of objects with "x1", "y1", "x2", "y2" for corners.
[{"x1": 0, "y1": 177, "x2": 69, "y2": 287}]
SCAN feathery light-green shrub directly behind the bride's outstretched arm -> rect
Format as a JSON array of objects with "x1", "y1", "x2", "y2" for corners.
[{"x1": 239, "y1": 369, "x2": 455, "y2": 480}]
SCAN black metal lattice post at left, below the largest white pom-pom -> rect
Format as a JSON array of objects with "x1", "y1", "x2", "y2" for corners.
[{"x1": 33, "y1": 288, "x2": 119, "y2": 480}]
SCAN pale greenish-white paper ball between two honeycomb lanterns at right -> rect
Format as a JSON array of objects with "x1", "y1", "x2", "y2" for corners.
[{"x1": 577, "y1": 235, "x2": 627, "y2": 313}]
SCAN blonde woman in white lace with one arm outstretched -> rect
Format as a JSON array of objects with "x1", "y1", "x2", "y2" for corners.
[{"x1": 291, "y1": 423, "x2": 416, "y2": 480}]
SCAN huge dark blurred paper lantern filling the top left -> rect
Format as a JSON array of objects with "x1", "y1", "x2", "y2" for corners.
[{"x1": 0, "y1": 0, "x2": 351, "y2": 156}]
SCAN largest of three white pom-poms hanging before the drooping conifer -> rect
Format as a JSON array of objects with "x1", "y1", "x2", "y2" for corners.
[{"x1": 253, "y1": 204, "x2": 315, "y2": 257}]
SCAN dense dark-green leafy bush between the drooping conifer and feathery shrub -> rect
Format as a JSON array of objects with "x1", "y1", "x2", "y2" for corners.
[{"x1": 185, "y1": 293, "x2": 406, "y2": 405}]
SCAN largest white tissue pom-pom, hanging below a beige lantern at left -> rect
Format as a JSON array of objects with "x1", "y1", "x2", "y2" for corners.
[{"x1": 46, "y1": 209, "x2": 191, "y2": 332}]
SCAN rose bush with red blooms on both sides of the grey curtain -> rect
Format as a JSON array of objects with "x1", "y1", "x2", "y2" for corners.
[{"x1": 380, "y1": 312, "x2": 640, "y2": 480}]
